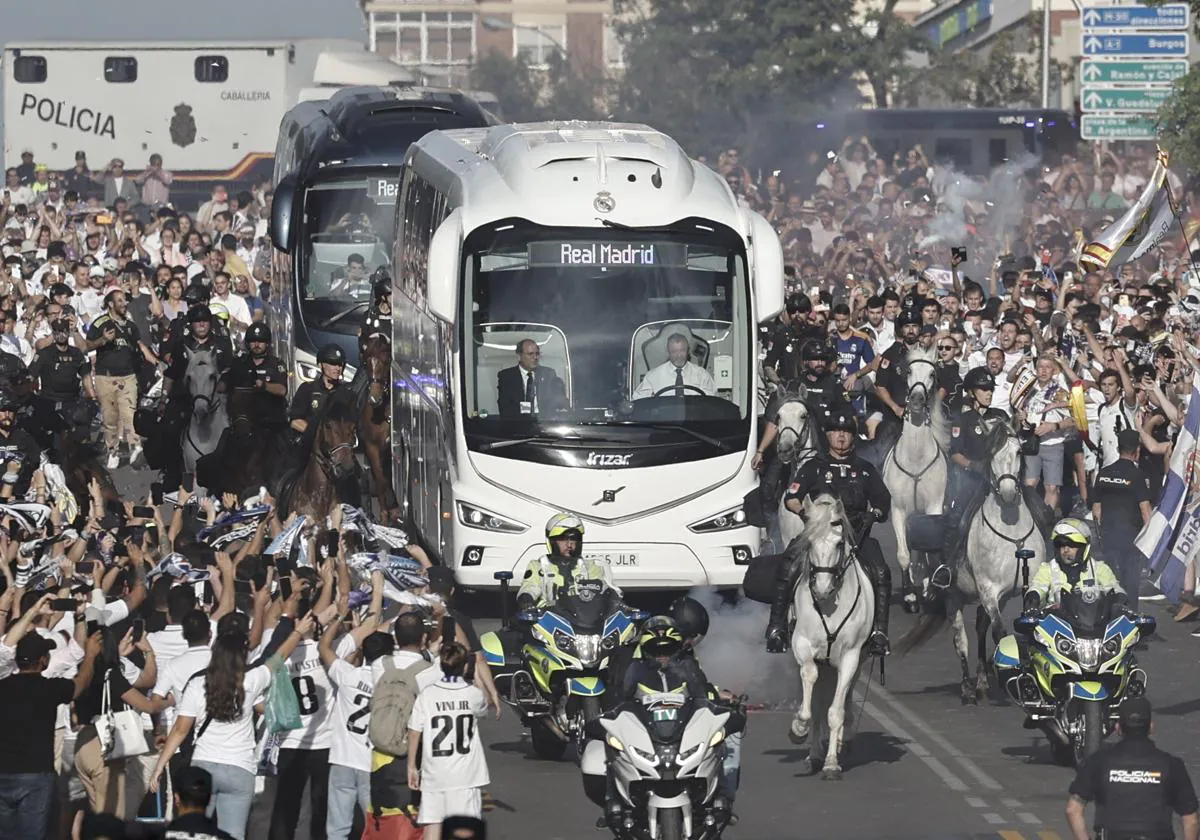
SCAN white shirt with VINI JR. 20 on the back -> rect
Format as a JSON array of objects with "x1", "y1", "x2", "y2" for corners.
[{"x1": 408, "y1": 677, "x2": 491, "y2": 791}]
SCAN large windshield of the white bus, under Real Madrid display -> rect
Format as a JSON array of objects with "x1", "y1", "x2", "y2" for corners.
[{"x1": 461, "y1": 223, "x2": 752, "y2": 457}]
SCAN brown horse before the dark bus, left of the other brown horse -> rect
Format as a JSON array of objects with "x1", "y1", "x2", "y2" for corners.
[{"x1": 276, "y1": 389, "x2": 360, "y2": 523}]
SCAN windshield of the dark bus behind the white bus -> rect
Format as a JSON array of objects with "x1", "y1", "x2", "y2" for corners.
[{"x1": 298, "y1": 175, "x2": 398, "y2": 335}]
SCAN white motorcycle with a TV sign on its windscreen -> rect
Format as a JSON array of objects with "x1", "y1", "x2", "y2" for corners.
[{"x1": 581, "y1": 694, "x2": 732, "y2": 840}]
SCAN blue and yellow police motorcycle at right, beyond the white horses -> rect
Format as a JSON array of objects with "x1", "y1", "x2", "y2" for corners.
[{"x1": 994, "y1": 590, "x2": 1157, "y2": 766}]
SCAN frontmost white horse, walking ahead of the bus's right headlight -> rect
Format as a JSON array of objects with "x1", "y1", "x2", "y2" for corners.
[{"x1": 787, "y1": 493, "x2": 875, "y2": 780}]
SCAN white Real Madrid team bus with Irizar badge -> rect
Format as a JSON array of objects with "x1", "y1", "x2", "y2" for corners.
[{"x1": 392, "y1": 122, "x2": 784, "y2": 589}]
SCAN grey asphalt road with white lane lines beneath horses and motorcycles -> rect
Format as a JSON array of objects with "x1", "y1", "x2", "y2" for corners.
[{"x1": 119, "y1": 469, "x2": 1200, "y2": 840}]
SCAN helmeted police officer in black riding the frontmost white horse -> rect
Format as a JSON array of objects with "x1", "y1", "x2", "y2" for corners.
[{"x1": 767, "y1": 407, "x2": 892, "y2": 656}]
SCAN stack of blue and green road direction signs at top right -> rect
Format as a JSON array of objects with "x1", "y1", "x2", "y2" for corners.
[{"x1": 1080, "y1": 2, "x2": 1192, "y2": 140}]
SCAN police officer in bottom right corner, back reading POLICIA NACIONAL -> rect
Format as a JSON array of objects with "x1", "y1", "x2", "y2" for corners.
[{"x1": 1067, "y1": 697, "x2": 1200, "y2": 840}]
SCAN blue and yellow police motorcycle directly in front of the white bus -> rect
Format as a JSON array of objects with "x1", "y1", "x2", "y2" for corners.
[{"x1": 480, "y1": 571, "x2": 649, "y2": 761}]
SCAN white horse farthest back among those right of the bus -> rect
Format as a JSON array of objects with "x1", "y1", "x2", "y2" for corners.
[{"x1": 883, "y1": 344, "x2": 950, "y2": 612}]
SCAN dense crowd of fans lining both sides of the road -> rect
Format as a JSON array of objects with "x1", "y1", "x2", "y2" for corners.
[{"x1": 0, "y1": 126, "x2": 1200, "y2": 840}]
